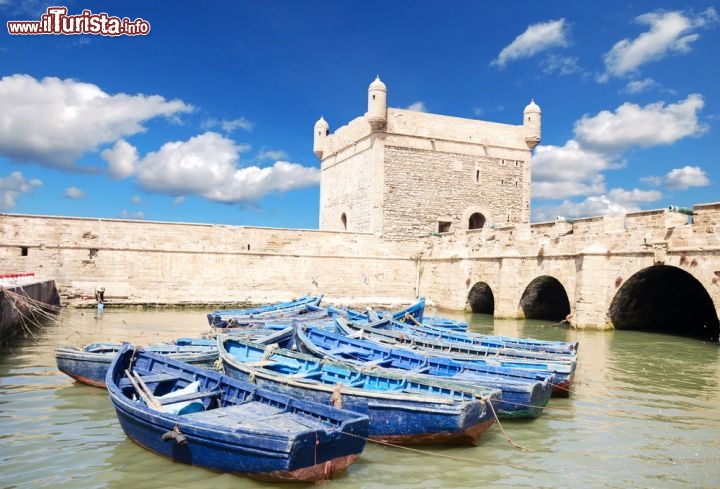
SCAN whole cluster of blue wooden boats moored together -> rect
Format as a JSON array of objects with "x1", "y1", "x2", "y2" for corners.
[{"x1": 55, "y1": 296, "x2": 578, "y2": 482}]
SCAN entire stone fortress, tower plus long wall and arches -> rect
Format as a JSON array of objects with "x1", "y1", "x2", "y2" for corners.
[{"x1": 0, "y1": 78, "x2": 720, "y2": 341}]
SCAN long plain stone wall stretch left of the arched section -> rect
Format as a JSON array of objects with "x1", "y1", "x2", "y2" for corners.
[{"x1": 0, "y1": 214, "x2": 416, "y2": 304}]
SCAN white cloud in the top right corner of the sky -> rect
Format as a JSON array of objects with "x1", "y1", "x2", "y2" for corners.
[{"x1": 603, "y1": 8, "x2": 718, "y2": 79}]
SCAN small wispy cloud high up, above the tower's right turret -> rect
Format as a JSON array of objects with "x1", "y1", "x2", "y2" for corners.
[{"x1": 490, "y1": 19, "x2": 569, "y2": 68}]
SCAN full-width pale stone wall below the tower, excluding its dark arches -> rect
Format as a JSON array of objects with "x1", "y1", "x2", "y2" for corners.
[{"x1": 0, "y1": 200, "x2": 720, "y2": 328}]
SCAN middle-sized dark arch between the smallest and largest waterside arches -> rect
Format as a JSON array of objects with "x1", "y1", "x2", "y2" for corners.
[{"x1": 520, "y1": 275, "x2": 570, "y2": 321}]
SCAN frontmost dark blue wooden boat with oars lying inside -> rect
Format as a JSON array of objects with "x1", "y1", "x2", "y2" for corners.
[{"x1": 106, "y1": 344, "x2": 369, "y2": 482}]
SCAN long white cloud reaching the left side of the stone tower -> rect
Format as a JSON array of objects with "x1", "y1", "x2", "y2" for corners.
[{"x1": 103, "y1": 132, "x2": 320, "y2": 203}]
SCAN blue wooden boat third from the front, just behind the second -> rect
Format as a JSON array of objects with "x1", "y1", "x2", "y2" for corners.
[{"x1": 295, "y1": 325, "x2": 555, "y2": 418}]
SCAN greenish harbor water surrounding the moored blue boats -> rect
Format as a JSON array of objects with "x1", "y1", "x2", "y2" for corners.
[{"x1": 0, "y1": 307, "x2": 720, "y2": 489}]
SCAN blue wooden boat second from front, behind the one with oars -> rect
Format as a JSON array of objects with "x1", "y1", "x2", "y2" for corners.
[{"x1": 218, "y1": 335, "x2": 500, "y2": 445}]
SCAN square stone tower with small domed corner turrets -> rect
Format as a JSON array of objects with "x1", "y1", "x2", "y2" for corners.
[{"x1": 313, "y1": 77, "x2": 542, "y2": 240}]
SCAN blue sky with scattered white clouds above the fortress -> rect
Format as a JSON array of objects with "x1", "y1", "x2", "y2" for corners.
[{"x1": 0, "y1": 0, "x2": 720, "y2": 229}]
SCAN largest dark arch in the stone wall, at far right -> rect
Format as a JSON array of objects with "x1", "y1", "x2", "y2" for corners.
[{"x1": 610, "y1": 265, "x2": 720, "y2": 342}]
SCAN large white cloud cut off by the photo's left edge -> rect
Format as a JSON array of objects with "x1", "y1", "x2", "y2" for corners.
[{"x1": 0, "y1": 75, "x2": 193, "y2": 168}]
